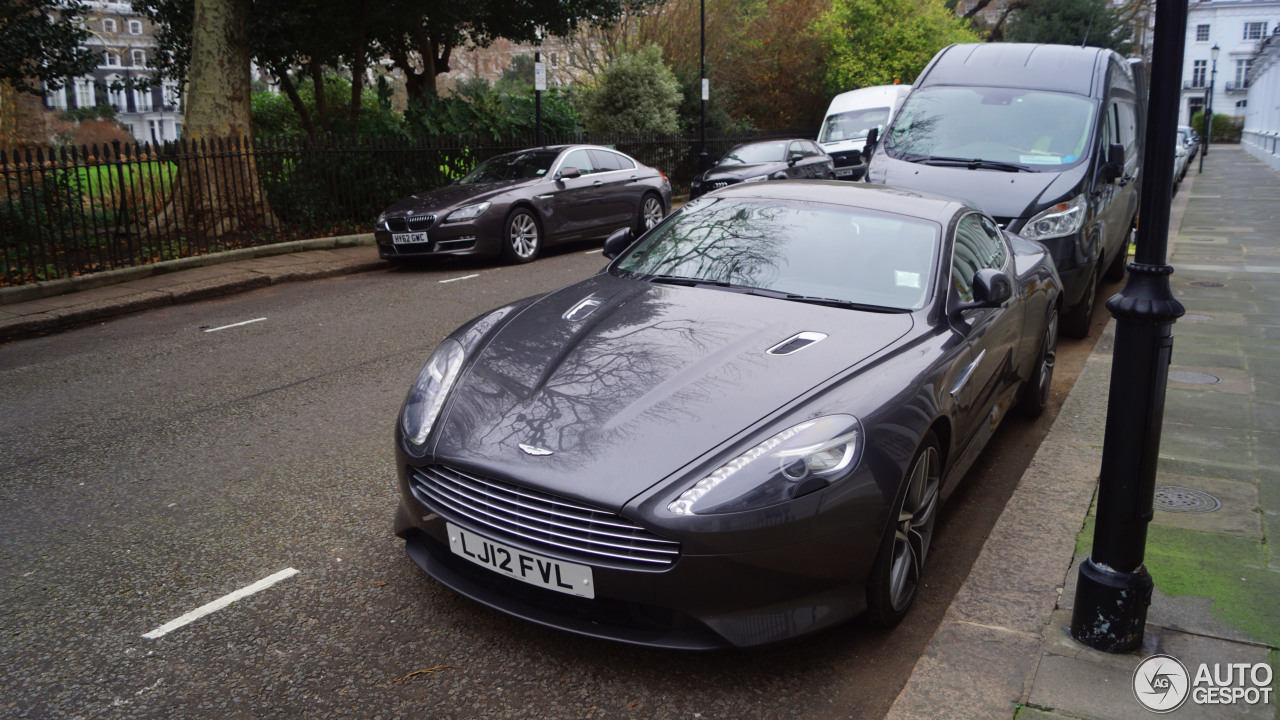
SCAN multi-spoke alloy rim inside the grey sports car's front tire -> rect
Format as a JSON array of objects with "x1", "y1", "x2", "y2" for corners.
[{"x1": 888, "y1": 446, "x2": 942, "y2": 611}]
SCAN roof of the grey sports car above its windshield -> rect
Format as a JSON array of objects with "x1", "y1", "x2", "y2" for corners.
[{"x1": 709, "y1": 181, "x2": 978, "y2": 225}]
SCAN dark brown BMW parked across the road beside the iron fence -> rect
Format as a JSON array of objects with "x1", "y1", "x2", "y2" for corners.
[{"x1": 374, "y1": 145, "x2": 671, "y2": 263}]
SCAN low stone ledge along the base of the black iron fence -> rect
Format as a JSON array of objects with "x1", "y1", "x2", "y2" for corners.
[{"x1": 0, "y1": 233, "x2": 374, "y2": 303}]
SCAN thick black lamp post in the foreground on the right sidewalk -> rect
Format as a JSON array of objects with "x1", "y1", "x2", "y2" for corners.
[{"x1": 1071, "y1": 0, "x2": 1187, "y2": 652}]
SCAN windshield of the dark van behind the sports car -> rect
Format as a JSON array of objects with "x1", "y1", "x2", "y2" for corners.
[{"x1": 886, "y1": 87, "x2": 1094, "y2": 170}]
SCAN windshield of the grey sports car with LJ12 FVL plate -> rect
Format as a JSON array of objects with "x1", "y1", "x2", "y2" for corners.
[{"x1": 614, "y1": 197, "x2": 940, "y2": 310}]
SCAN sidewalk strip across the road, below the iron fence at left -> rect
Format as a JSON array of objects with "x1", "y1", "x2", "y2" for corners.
[{"x1": 0, "y1": 233, "x2": 378, "y2": 342}]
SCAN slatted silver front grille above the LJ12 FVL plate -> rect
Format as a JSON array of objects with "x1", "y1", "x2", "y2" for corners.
[{"x1": 408, "y1": 465, "x2": 680, "y2": 570}]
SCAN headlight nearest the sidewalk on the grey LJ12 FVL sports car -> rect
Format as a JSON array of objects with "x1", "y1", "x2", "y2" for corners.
[{"x1": 667, "y1": 415, "x2": 864, "y2": 515}]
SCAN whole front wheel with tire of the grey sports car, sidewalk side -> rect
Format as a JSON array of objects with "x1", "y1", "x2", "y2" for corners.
[{"x1": 867, "y1": 430, "x2": 942, "y2": 628}]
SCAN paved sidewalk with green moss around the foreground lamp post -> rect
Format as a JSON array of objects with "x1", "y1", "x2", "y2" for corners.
[{"x1": 888, "y1": 146, "x2": 1280, "y2": 720}]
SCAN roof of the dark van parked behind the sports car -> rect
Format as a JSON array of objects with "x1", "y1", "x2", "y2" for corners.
[{"x1": 915, "y1": 42, "x2": 1110, "y2": 97}]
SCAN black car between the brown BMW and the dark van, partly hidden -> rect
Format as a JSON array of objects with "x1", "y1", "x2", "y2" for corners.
[{"x1": 689, "y1": 140, "x2": 836, "y2": 199}]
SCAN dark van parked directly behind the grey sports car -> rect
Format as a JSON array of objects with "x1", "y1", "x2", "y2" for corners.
[{"x1": 867, "y1": 42, "x2": 1147, "y2": 337}]
